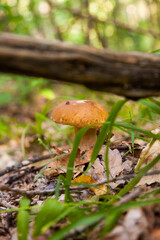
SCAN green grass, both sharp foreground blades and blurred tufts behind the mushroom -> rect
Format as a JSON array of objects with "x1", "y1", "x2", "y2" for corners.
[{"x1": 0, "y1": 74, "x2": 160, "y2": 240}]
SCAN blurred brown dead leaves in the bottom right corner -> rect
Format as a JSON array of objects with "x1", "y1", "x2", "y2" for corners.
[{"x1": 87, "y1": 205, "x2": 160, "y2": 240}]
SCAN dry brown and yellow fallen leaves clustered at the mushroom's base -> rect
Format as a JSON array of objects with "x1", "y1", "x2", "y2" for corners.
[{"x1": 44, "y1": 145, "x2": 132, "y2": 195}]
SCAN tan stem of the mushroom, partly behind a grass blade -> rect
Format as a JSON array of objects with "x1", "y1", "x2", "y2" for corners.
[{"x1": 75, "y1": 127, "x2": 97, "y2": 152}]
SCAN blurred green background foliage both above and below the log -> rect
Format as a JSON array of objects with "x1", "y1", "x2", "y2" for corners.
[{"x1": 0, "y1": 0, "x2": 160, "y2": 153}]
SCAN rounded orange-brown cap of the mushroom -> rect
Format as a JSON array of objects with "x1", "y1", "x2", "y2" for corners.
[{"x1": 52, "y1": 100, "x2": 108, "y2": 128}]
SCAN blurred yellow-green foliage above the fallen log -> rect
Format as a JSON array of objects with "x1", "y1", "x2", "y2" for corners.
[{"x1": 0, "y1": 0, "x2": 160, "y2": 52}]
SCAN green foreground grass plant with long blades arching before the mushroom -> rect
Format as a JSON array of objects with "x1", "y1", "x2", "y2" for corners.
[{"x1": 13, "y1": 101, "x2": 160, "y2": 240}]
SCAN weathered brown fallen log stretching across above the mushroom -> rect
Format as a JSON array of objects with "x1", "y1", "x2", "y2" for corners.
[{"x1": 0, "y1": 34, "x2": 160, "y2": 99}]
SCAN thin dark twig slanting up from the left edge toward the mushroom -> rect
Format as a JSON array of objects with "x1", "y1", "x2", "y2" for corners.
[{"x1": 0, "y1": 153, "x2": 56, "y2": 177}]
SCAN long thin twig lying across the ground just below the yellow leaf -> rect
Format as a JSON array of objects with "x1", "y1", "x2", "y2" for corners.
[{"x1": 0, "y1": 170, "x2": 160, "y2": 197}]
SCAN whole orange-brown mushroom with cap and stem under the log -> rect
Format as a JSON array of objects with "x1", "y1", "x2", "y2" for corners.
[{"x1": 52, "y1": 100, "x2": 108, "y2": 152}]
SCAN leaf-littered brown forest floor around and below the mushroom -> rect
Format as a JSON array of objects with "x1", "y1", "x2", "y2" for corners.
[{"x1": 0, "y1": 79, "x2": 160, "y2": 240}]
